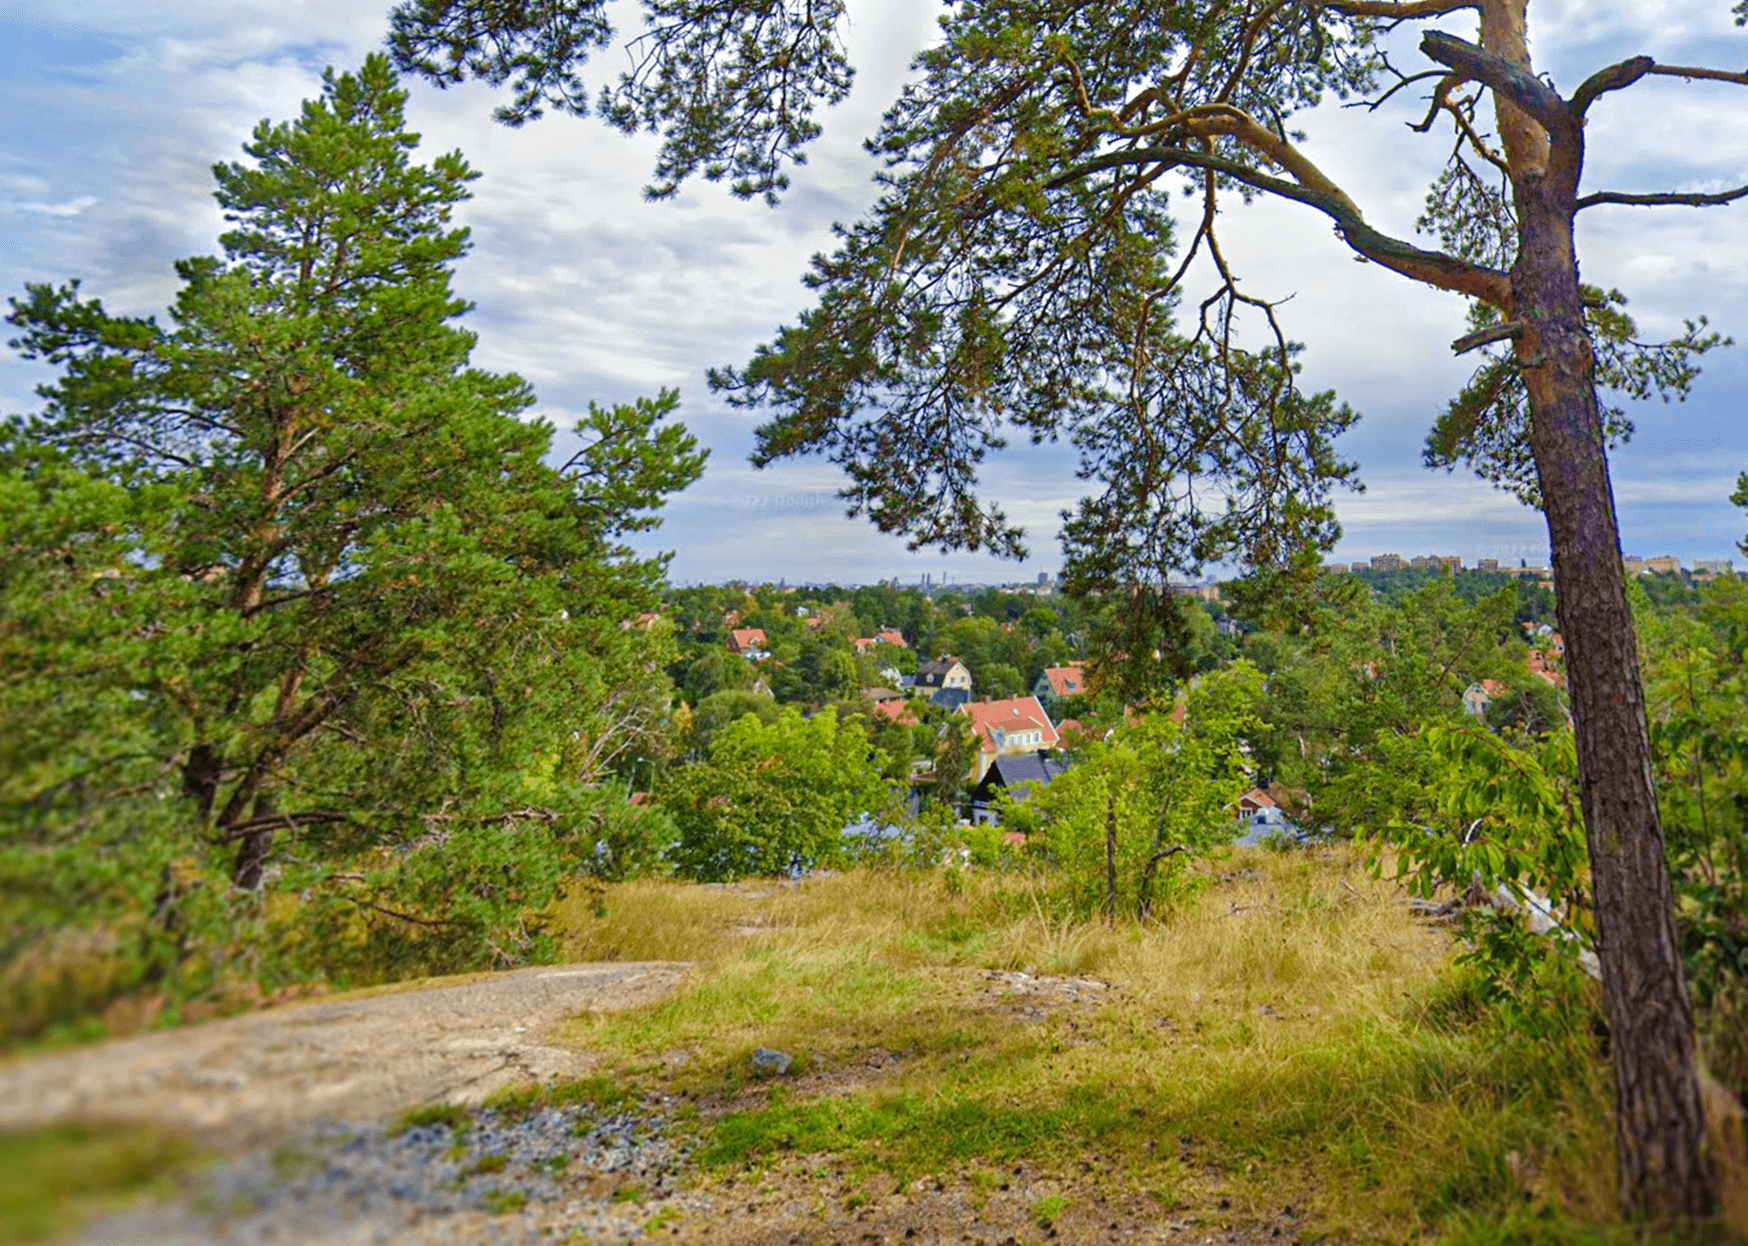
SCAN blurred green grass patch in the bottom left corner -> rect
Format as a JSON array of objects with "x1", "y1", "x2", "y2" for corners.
[{"x1": 0, "y1": 1122, "x2": 194, "y2": 1243}]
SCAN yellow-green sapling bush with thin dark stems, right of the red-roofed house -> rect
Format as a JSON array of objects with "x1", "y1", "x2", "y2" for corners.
[{"x1": 1003, "y1": 662, "x2": 1262, "y2": 917}]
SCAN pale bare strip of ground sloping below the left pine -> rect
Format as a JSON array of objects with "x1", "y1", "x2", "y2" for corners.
[{"x1": 0, "y1": 963, "x2": 687, "y2": 1145}]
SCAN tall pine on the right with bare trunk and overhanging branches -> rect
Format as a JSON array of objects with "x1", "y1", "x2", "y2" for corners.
[{"x1": 392, "y1": 0, "x2": 1748, "y2": 1216}]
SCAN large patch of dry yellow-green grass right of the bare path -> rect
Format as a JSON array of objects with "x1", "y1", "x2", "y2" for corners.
[{"x1": 559, "y1": 848, "x2": 1650, "y2": 1243}]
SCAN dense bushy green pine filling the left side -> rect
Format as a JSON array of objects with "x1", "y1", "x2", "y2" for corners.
[{"x1": 0, "y1": 56, "x2": 703, "y2": 1038}]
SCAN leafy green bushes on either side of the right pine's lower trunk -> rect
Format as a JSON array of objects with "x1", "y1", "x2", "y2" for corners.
[{"x1": 1363, "y1": 578, "x2": 1748, "y2": 1090}]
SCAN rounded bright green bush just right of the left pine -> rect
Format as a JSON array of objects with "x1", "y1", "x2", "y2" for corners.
[{"x1": 662, "y1": 708, "x2": 893, "y2": 883}]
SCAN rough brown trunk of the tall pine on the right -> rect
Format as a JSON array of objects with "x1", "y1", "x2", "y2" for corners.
[{"x1": 1512, "y1": 102, "x2": 1717, "y2": 1220}]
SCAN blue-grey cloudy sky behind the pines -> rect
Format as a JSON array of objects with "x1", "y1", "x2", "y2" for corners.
[{"x1": 0, "y1": 0, "x2": 1748, "y2": 582}]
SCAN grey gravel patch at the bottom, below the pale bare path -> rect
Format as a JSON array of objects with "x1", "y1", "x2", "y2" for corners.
[{"x1": 77, "y1": 1106, "x2": 703, "y2": 1246}]
